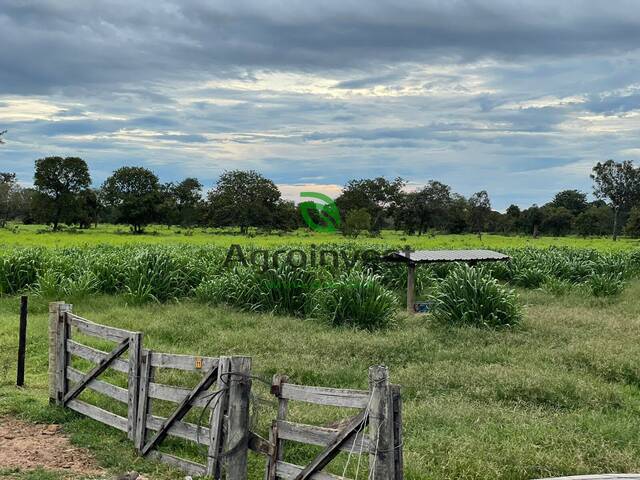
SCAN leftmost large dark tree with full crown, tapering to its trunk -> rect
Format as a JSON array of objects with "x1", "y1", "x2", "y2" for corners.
[{"x1": 33, "y1": 157, "x2": 91, "y2": 230}]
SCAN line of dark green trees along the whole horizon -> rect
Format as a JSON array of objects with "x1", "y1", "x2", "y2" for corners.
[{"x1": 0, "y1": 157, "x2": 640, "y2": 239}]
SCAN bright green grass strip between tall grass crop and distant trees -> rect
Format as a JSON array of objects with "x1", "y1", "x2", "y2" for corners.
[{"x1": 0, "y1": 224, "x2": 640, "y2": 250}]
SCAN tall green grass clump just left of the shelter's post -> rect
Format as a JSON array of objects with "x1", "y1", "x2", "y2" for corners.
[{"x1": 315, "y1": 271, "x2": 398, "y2": 330}]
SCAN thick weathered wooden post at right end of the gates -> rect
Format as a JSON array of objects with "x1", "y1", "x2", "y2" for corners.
[{"x1": 369, "y1": 365, "x2": 395, "y2": 480}]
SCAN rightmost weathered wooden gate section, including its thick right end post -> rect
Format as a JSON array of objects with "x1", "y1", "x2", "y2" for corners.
[{"x1": 265, "y1": 366, "x2": 403, "y2": 480}]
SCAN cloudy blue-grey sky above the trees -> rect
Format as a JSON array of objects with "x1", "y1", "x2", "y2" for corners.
[{"x1": 0, "y1": 0, "x2": 640, "y2": 209}]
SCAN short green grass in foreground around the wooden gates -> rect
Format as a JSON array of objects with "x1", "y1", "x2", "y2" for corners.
[{"x1": 0, "y1": 284, "x2": 640, "y2": 480}]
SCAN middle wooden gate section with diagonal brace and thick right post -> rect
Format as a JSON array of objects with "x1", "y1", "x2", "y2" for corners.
[{"x1": 136, "y1": 350, "x2": 251, "y2": 478}]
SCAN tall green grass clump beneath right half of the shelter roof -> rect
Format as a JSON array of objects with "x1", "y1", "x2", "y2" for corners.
[{"x1": 432, "y1": 265, "x2": 522, "y2": 327}]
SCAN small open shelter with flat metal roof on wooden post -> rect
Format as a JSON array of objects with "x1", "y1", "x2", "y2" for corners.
[{"x1": 382, "y1": 248, "x2": 510, "y2": 313}]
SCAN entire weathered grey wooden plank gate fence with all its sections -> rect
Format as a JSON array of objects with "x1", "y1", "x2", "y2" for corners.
[{"x1": 49, "y1": 302, "x2": 403, "y2": 480}]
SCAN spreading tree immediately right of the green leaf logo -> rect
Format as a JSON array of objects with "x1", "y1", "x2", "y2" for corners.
[{"x1": 336, "y1": 177, "x2": 406, "y2": 231}]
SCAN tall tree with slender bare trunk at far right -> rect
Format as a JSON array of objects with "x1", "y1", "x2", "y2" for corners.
[{"x1": 590, "y1": 160, "x2": 640, "y2": 241}]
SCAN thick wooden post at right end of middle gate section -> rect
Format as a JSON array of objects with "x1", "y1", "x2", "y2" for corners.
[{"x1": 225, "y1": 357, "x2": 251, "y2": 480}]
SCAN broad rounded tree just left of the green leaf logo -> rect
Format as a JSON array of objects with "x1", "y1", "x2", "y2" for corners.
[{"x1": 208, "y1": 170, "x2": 280, "y2": 234}]
